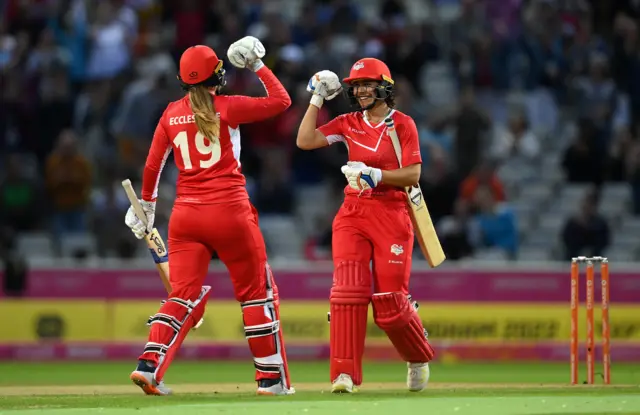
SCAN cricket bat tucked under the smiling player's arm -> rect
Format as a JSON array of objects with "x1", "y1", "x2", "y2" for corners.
[{"x1": 384, "y1": 117, "x2": 446, "y2": 268}]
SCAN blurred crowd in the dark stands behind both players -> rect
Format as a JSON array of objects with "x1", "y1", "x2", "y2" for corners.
[{"x1": 0, "y1": 0, "x2": 640, "y2": 266}]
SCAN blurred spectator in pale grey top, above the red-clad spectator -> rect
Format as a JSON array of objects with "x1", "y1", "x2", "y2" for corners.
[{"x1": 490, "y1": 111, "x2": 540, "y2": 188}]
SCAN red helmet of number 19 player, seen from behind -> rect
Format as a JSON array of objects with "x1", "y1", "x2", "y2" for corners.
[{"x1": 178, "y1": 45, "x2": 226, "y2": 89}]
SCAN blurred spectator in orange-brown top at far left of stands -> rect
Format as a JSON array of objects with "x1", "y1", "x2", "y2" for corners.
[{"x1": 45, "y1": 130, "x2": 92, "y2": 238}]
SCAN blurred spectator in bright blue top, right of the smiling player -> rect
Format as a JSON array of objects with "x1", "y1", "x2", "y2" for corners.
[{"x1": 471, "y1": 186, "x2": 519, "y2": 259}]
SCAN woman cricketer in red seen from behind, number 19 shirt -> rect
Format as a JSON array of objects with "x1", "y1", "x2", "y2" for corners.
[{"x1": 125, "y1": 36, "x2": 295, "y2": 395}]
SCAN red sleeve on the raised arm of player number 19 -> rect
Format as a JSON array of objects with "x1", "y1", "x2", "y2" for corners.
[{"x1": 220, "y1": 66, "x2": 291, "y2": 126}]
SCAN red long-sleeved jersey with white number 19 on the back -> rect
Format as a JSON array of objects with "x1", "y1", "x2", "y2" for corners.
[{"x1": 142, "y1": 66, "x2": 291, "y2": 204}]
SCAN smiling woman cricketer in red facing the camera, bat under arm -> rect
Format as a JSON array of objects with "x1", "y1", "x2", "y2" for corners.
[{"x1": 297, "y1": 58, "x2": 434, "y2": 393}]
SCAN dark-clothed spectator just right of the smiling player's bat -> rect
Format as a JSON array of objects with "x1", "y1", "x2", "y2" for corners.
[{"x1": 436, "y1": 199, "x2": 474, "y2": 261}]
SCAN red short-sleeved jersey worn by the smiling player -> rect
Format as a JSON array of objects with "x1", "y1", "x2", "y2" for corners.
[{"x1": 318, "y1": 110, "x2": 422, "y2": 200}]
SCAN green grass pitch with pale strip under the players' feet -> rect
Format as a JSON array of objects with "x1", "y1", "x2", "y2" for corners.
[{"x1": 0, "y1": 362, "x2": 640, "y2": 415}]
